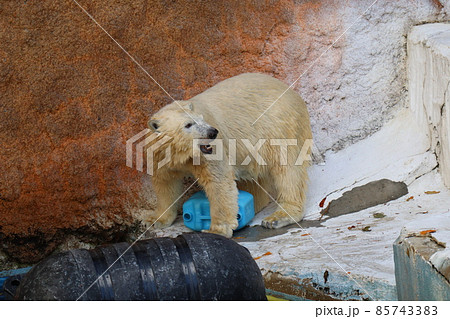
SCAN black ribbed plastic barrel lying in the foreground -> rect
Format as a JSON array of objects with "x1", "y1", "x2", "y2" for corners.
[{"x1": 16, "y1": 233, "x2": 267, "y2": 300}]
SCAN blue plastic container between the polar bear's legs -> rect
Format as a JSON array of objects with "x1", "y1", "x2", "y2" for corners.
[{"x1": 183, "y1": 191, "x2": 255, "y2": 231}]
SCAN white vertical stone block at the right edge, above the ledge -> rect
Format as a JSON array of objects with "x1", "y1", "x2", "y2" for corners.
[{"x1": 408, "y1": 23, "x2": 450, "y2": 187}]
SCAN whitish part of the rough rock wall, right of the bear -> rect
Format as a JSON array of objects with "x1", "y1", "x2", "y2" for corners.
[{"x1": 284, "y1": 0, "x2": 450, "y2": 152}]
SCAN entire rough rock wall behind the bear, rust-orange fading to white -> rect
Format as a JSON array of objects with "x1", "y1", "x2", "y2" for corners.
[{"x1": 0, "y1": 0, "x2": 449, "y2": 262}]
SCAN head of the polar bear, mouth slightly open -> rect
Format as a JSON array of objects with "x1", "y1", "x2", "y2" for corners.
[{"x1": 148, "y1": 101, "x2": 219, "y2": 159}]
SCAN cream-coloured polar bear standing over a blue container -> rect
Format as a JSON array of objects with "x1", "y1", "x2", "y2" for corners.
[{"x1": 147, "y1": 73, "x2": 312, "y2": 238}]
